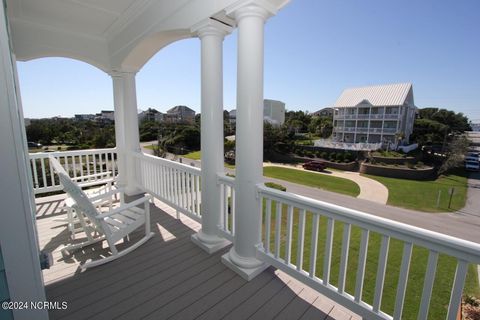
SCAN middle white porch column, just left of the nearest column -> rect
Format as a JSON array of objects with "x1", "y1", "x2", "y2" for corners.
[{"x1": 192, "y1": 19, "x2": 231, "y2": 253}]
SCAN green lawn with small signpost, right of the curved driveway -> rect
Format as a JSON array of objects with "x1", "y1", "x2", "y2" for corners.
[{"x1": 365, "y1": 170, "x2": 467, "y2": 212}]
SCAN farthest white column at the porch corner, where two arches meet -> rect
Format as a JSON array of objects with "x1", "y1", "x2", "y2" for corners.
[{"x1": 111, "y1": 72, "x2": 140, "y2": 195}]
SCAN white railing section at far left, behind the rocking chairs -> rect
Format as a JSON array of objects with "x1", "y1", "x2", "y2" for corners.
[{"x1": 29, "y1": 148, "x2": 117, "y2": 194}]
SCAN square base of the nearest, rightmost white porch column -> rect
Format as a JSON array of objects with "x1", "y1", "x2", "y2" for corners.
[{"x1": 222, "y1": 248, "x2": 270, "y2": 281}]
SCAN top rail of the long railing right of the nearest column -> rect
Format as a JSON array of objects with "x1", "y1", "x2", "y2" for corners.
[{"x1": 257, "y1": 184, "x2": 480, "y2": 264}]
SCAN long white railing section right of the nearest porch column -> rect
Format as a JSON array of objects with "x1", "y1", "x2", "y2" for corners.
[{"x1": 257, "y1": 184, "x2": 480, "y2": 320}]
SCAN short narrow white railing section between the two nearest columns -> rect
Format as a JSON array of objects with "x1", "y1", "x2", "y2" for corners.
[{"x1": 218, "y1": 175, "x2": 235, "y2": 242}]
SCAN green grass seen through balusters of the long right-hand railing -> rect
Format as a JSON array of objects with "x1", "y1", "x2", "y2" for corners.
[{"x1": 262, "y1": 202, "x2": 480, "y2": 319}]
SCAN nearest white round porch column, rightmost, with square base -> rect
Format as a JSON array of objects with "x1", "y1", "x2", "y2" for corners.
[{"x1": 222, "y1": 2, "x2": 270, "y2": 280}]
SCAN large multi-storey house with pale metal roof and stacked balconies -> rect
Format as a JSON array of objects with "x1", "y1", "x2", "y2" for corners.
[{"x1": 333, "y1": 83, "x2": 416, "y2": 143}]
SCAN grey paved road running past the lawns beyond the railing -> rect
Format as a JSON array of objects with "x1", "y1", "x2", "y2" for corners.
[{"x1": 136, "y1": 149, "x2": 480, "y2": 243}]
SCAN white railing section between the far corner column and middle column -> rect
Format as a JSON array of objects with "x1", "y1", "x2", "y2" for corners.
[{"x1": 134, "y1": 153, "x2": 201, "y2": 222}]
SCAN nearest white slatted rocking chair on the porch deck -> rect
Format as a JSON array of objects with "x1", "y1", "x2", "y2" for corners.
[{"x1": 50, "y1": 157, "x2": 153, "y2": 269}]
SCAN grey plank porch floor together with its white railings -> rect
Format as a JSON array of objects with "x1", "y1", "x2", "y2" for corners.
[{"x1": 31, "y1": 149, "x2": 480, "y2": 319}]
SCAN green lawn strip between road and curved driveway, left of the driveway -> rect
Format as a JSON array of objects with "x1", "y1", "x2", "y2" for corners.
[{"x1": 263, "y1": 167, "x2": 360, "y2": 197}]
